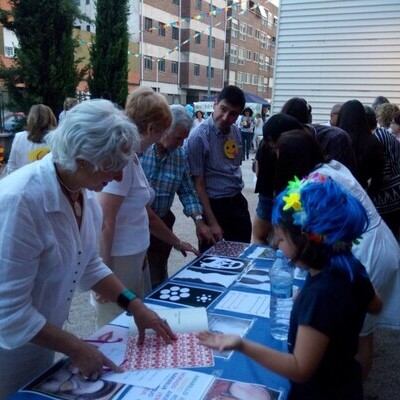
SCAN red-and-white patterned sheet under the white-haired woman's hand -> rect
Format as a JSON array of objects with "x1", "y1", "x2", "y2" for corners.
[{"x1": 123, "y1": 333, "x2": 214, "y2": 370}]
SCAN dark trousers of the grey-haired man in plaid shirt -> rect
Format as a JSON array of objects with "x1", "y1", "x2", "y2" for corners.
[{"x1": 147, "y1": 210, "x2": 175, "y2": 289}]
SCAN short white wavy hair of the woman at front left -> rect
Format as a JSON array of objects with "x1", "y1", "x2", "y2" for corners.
[{"x1": 46, "y1": 99, "x2": 140, "y2": 172}]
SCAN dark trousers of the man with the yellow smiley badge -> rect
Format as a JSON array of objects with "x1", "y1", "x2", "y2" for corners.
[{"x1": 200, "y1": 193, "x2": 251, "y2": 252}]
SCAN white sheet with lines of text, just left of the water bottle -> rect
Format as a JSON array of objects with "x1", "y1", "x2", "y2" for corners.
[{"x1": 215, "y1": 290, "x2": 271, "y2": 318}]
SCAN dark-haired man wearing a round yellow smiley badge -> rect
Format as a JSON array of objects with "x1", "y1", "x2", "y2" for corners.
[{"x1": 186, "y1": 86, "x2": 251, "y2": 250}]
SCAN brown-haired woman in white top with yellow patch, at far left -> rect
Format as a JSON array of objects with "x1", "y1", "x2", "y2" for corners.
[{"x1": 6, "y1": 104, "x2": 57, "y2": 174}]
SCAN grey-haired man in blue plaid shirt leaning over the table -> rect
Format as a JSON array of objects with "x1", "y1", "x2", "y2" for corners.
[{"x1": 140, "y1": 105, "x2": 214, "y2": 288}]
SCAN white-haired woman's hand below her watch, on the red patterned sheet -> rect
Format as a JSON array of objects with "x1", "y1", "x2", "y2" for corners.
[{"x1": 128, "y1": 299, "x2": 177, "y2": 344}]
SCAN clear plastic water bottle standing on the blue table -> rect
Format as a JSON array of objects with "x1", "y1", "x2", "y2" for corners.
[{"x1": 270, "y1": 250, "x2": 294, "y2": 340}]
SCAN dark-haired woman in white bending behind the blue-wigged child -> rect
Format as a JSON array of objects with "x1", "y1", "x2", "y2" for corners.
[{"x1": 275, "y1": 130, "x2": 400, "y2": 382}]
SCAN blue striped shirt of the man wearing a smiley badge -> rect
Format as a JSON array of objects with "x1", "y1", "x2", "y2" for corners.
[{"x1": 185, "y1": 116, "x2": 244, "y2": 199}]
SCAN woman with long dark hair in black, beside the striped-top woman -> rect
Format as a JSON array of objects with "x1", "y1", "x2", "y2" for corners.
[{"x1": 337, "y1": 100, "x2": 384, "y2": 193}]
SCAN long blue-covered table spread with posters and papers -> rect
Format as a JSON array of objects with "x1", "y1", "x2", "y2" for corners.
[{"x1": 11, "y1": 241, "x2": 304, "y2": 400}]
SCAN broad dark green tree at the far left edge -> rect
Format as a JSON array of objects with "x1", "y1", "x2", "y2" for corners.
[{"x1": 0, "y1": 0, "x2": 84, "y2": 115}]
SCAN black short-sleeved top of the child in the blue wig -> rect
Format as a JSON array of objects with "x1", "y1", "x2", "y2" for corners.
[{"x1": 288, "y1": 267, "x2": 375, "y2": 400}]
